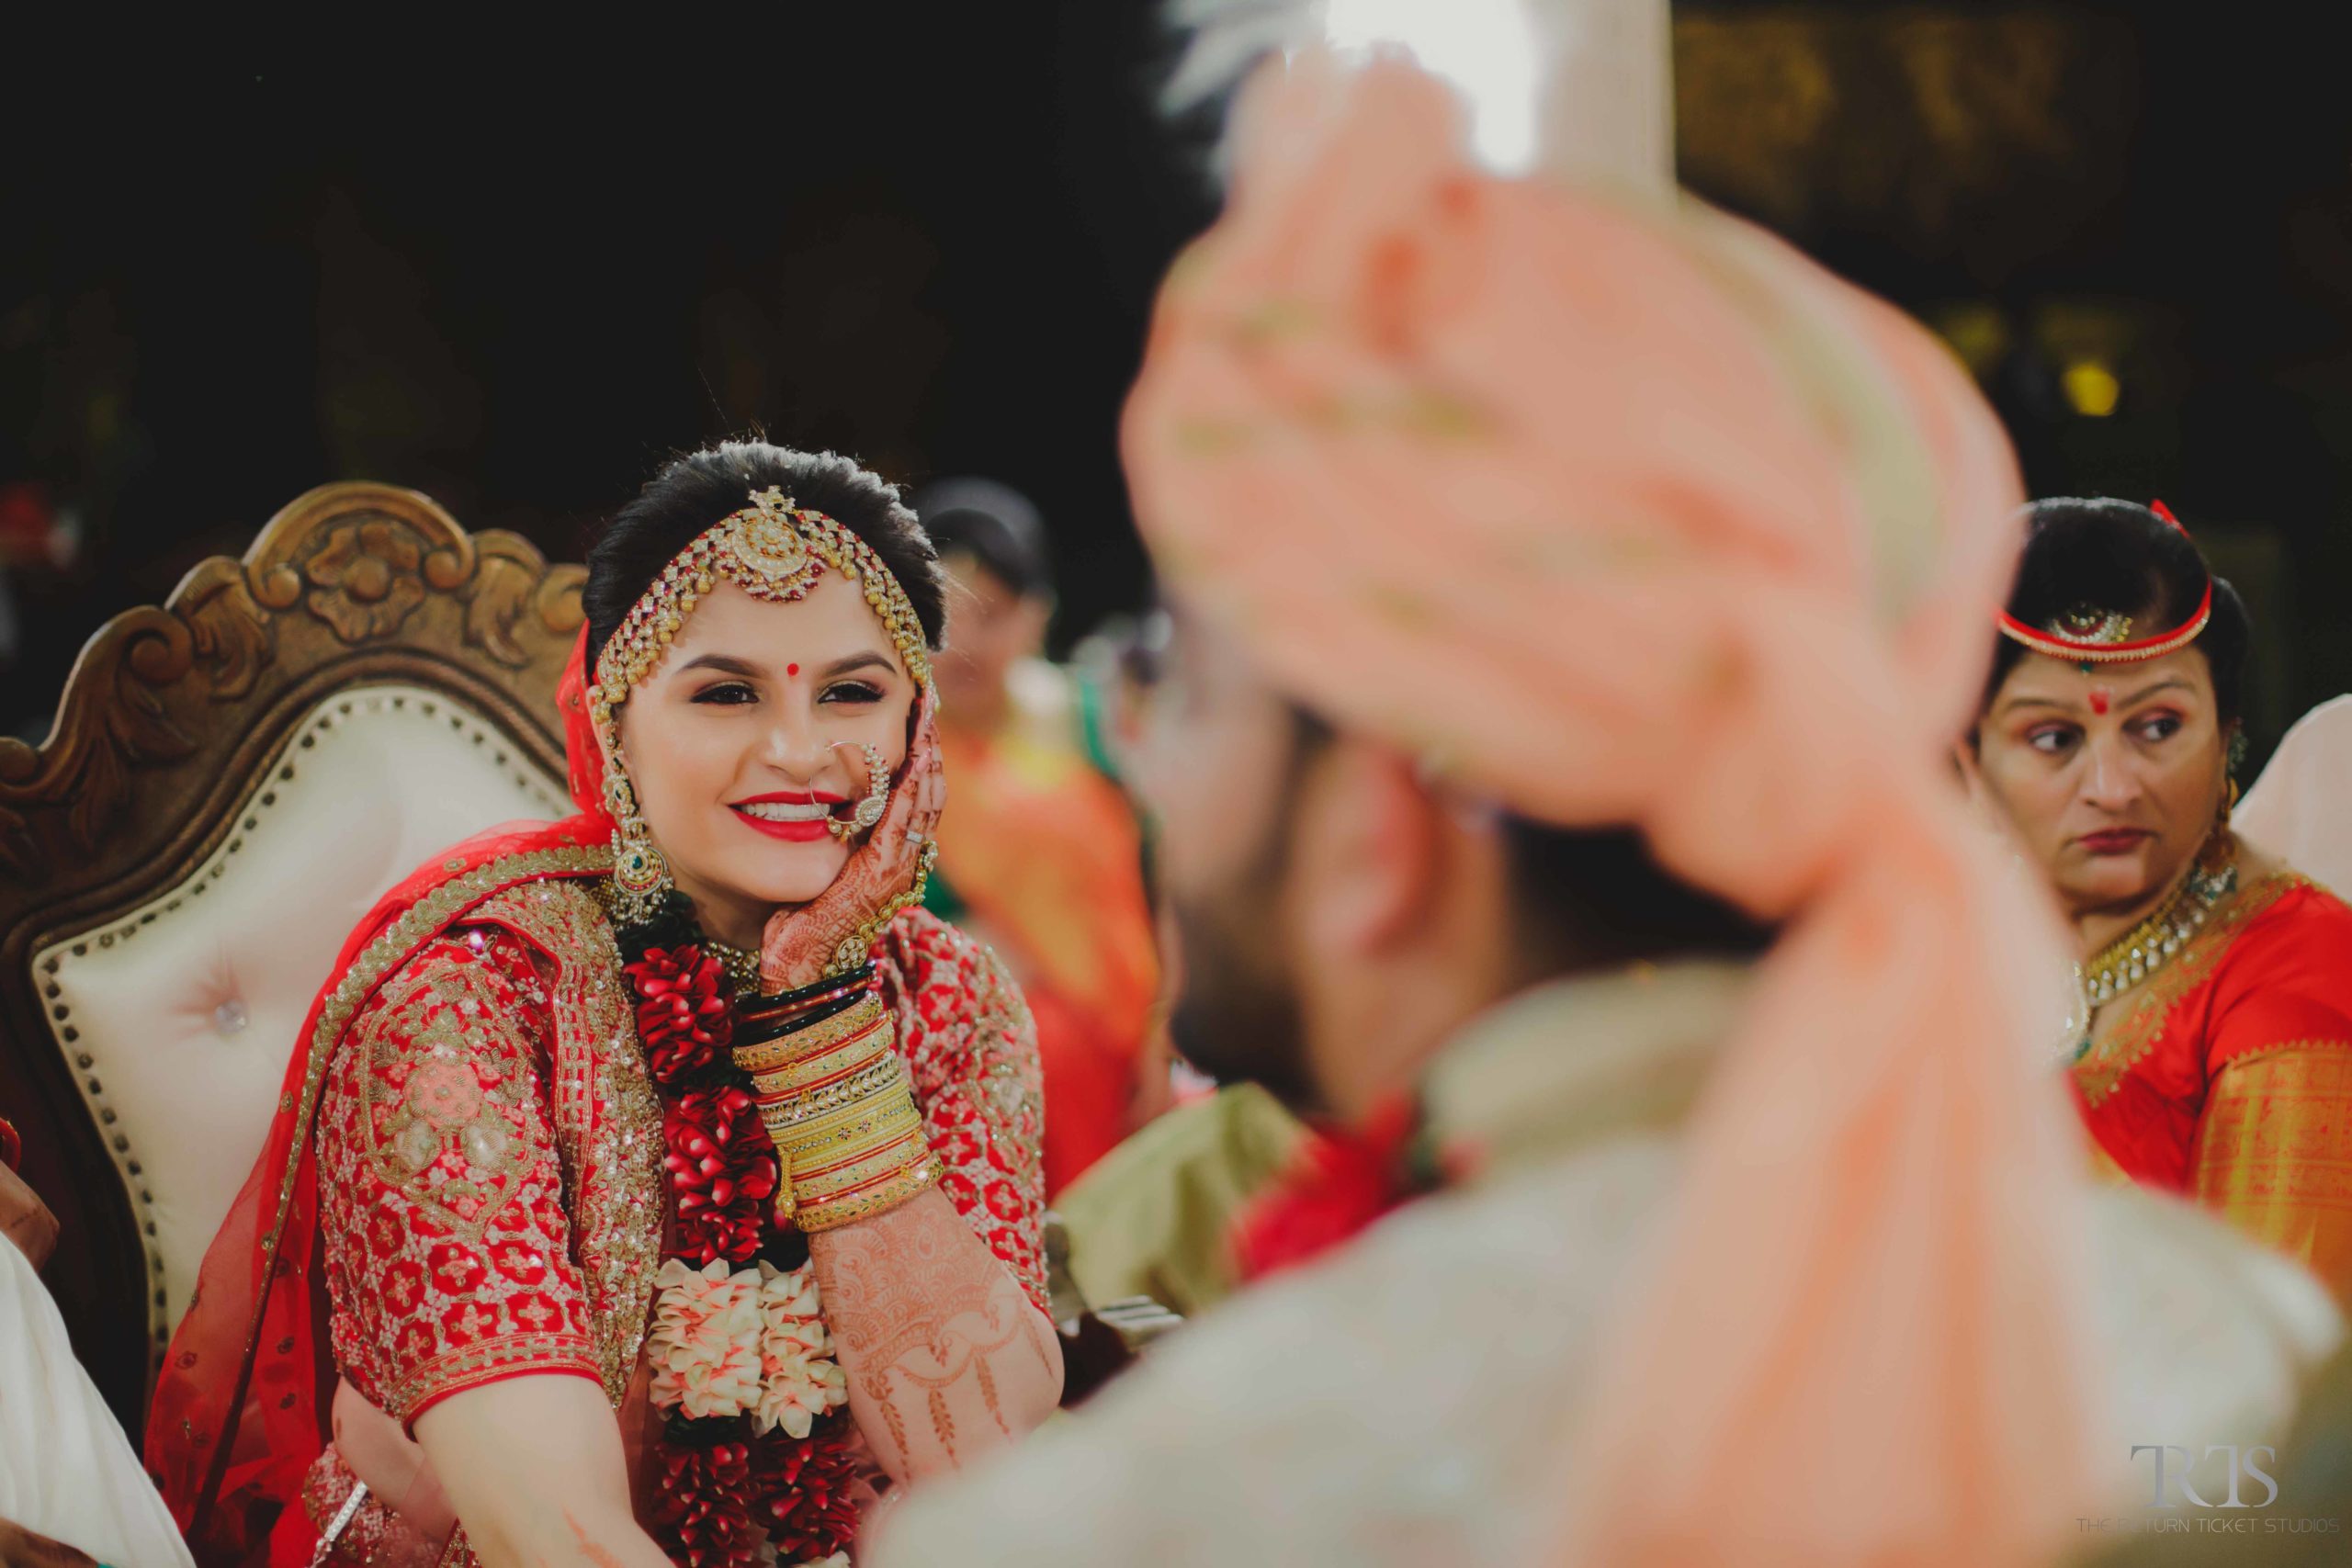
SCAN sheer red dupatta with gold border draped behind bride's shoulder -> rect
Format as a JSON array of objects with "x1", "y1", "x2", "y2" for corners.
[{"x1": 146, "y1": 627, "x2": 612, "y2": 1565}]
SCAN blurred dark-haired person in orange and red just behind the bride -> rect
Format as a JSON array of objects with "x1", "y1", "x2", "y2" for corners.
[{"x1": 917, "y1": 479, "x2": 1167, "y2": 1199}]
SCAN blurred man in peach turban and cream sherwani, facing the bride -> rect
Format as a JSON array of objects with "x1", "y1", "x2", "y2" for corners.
[{"x1": 861, "y1": 36, "x2": 2340, "y2": 1568}]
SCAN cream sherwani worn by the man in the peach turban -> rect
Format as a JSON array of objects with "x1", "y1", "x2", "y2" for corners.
[{"x1": 861, "y1": 966, "x2": 2340, "y2": 1568}]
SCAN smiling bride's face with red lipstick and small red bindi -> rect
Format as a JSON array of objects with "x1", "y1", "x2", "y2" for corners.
[{"x1": 616, "y1": 571, "x2": 917, "y2": 947}]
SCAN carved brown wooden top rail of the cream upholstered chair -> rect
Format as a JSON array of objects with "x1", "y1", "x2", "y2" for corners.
[{"x1": 0, "y1": 484, "x2": 583, "y2": 884}]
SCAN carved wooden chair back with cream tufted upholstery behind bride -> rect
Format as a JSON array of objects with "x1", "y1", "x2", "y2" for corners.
[{"x1": 0, "y1": 484, "x2": 583, "y2": 1432}]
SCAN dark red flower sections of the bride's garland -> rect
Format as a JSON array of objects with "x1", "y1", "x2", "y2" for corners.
[{"x1": 623, "y1": 942, "x2": 858, "y2": 1568}]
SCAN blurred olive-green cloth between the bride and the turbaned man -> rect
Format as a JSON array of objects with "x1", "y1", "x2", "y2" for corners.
[{"x1": 1054, "y1": 1084, "x2": 1301, "y2": 1316}]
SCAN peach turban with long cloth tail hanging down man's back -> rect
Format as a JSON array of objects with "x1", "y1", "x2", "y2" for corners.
[{"x1": 1125, "y1": 54, "x2": 2096, "y2": 1568}]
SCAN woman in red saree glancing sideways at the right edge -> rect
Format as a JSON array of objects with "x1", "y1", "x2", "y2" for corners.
[{"x1": 1973, "y1": 501, "x2": 2352, "y2": 1303}]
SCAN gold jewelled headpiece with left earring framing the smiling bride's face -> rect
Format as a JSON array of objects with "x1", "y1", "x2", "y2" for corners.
[{"x1": 588, "y1": 484, "x2": 932, "y2": 924}]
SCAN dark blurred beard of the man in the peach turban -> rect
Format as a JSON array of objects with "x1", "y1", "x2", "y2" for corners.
[{"x1": 1169, "y1": 797, "x2": 1322, "y2": 1112}]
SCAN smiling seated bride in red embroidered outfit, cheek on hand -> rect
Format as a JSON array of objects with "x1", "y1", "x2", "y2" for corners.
[{"x1": 148, "y1": 442, "x2": 1061, "y2": 1568}]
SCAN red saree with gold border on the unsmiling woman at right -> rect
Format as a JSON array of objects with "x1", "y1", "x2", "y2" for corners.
[{"x1": 2072, "y1": 831, "x2": 2352, "y2": 1304}]
